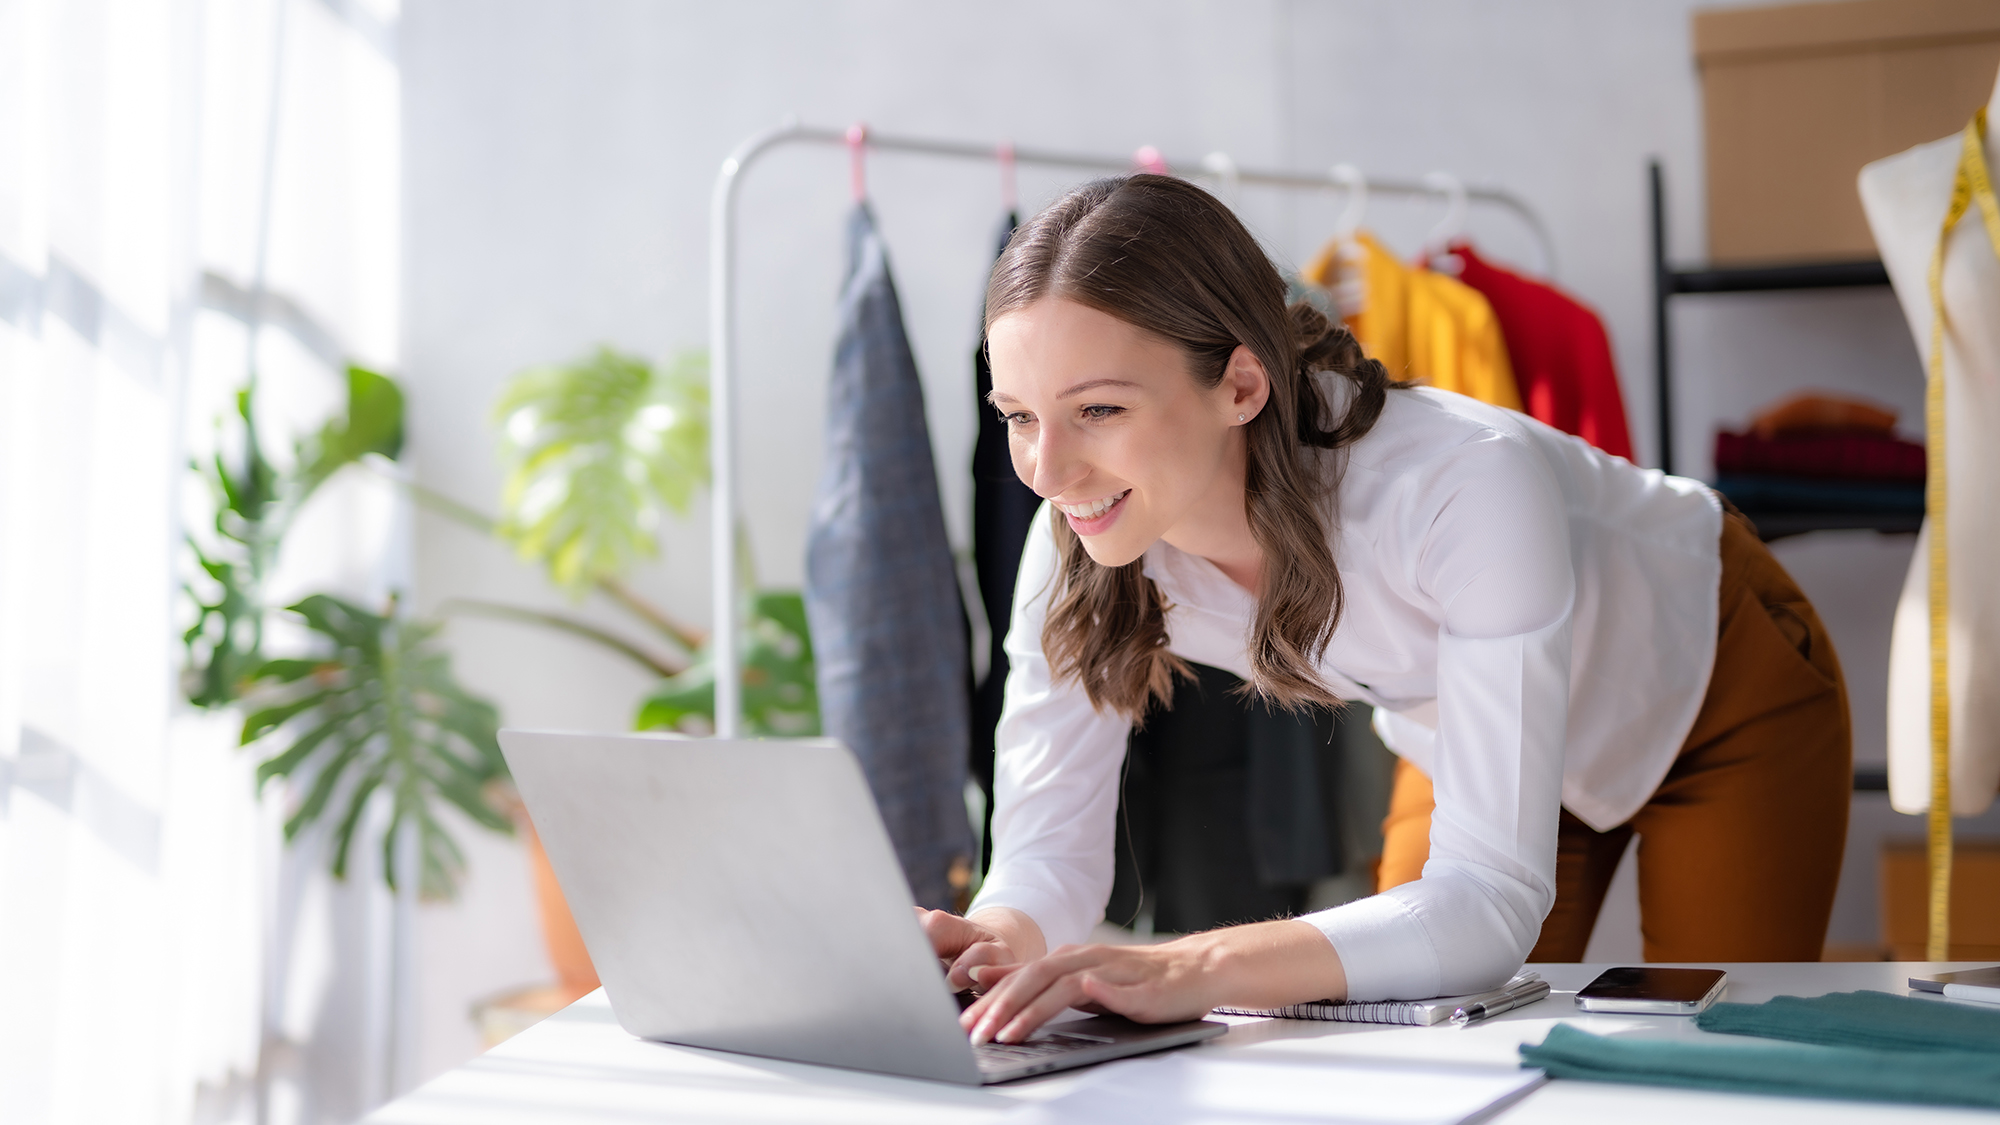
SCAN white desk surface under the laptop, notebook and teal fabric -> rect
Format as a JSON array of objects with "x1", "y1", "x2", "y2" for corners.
[{"x1": 368, "y1": 963, "x2": 2000, "y2": 1125}]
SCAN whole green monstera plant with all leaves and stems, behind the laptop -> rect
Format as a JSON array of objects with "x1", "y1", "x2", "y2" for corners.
[{"x1": 184, "y1": 348, "x2": 820, "y2": 897}]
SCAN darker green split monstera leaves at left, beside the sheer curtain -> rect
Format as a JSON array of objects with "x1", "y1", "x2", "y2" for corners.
[{"x1": 182, "y1": 366, "x2": 512, "y2": 899}]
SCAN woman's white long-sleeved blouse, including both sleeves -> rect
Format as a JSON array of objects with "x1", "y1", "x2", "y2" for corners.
[{"x1": 972, "y1": 374, "x2": 1722, "y2": 1001}]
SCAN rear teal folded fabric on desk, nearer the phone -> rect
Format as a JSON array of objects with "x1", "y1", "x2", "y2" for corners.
[{"x1": 1694, "y1": 980, "x2": 2000, "y2": 1055}]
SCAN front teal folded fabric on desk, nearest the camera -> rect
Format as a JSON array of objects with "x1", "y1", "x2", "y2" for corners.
[{"x1": 1520, "y1": 1023, "x2": 2000, "y2": 1107}]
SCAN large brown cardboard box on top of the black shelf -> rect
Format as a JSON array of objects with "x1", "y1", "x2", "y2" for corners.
[{"x1": 1694, "y1": 0, "x2": 2000, "y2": 264}]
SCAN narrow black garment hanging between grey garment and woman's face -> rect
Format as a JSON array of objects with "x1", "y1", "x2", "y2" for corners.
[{"x1": 970, "y1": 214, "x2": 1042, "y2": 869}]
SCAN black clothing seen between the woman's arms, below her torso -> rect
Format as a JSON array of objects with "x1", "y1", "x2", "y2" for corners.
[{"x1": 1104, "y1": 665, "x2": 1344, "y2": 933}]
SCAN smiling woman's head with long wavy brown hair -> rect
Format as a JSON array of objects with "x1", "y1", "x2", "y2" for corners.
[{"x1": 986, "y1": 174, "x2": 1390, "y2": 721}]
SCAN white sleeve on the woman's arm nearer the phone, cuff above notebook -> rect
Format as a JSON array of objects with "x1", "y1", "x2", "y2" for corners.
[{"x1": 1306, "y1": 426, "x2": 1574, "y2": 999}]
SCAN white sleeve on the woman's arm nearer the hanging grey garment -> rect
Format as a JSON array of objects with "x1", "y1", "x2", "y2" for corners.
[{"x1": 968, "y1": 504, "x2": 1132, "y2": 949}]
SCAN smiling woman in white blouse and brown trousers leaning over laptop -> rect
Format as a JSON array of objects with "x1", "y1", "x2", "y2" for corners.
[{"x1": 922, "y1": 174, "x2": 1850, "y2": 1043}]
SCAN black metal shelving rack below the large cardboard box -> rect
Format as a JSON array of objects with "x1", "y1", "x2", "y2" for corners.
[{"x1": 1650, "y1": 160, "x2": 1924, "y2": 540}]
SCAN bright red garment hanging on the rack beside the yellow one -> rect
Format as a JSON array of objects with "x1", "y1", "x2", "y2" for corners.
[{"x1": 1452, "y1": 242, "x2": 1632, "y2": 460}]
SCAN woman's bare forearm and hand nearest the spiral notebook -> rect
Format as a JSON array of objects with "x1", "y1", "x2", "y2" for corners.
[{"x1": 958, "y1": 921, "x2": 1348, "y2": 1043}]
